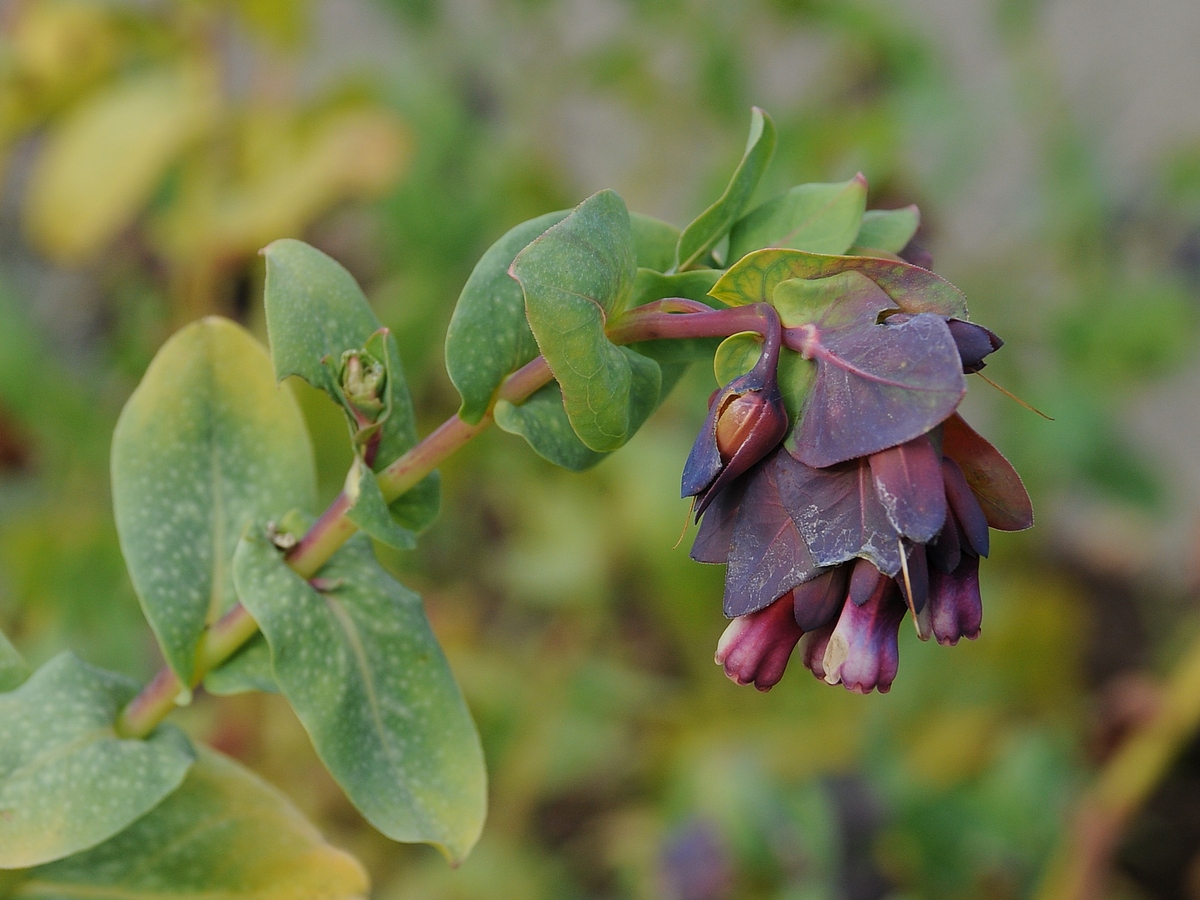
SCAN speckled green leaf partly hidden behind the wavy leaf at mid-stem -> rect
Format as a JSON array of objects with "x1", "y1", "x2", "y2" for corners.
[{"x1": 445, "y1": 210, "x2": 569, "y2": 425}]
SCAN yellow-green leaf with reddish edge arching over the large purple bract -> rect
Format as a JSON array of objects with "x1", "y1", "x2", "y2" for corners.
[{"x1": 710, "y1": 248, "x2": 967, "y2": 319}]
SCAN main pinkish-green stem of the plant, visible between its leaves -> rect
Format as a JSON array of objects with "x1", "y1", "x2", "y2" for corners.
[{"x1": 116, "y1": 298, "x2": 775, "y2": 738}]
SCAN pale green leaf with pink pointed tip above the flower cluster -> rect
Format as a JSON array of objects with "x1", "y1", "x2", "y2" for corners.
[{"x1": 730, "y1": 173, "x2": 866, "y2": 262}]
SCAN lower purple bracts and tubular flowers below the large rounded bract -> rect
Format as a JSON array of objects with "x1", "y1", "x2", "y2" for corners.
[{"x1": 692, "y1": 415, "x2": 1032, "y2": 694}]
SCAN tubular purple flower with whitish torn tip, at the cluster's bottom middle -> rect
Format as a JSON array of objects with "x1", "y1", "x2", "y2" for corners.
[{"x1": 814, "y1": 578, "x2": 907, "y2": 694}]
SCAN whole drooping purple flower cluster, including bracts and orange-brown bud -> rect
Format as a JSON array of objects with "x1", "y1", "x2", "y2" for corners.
[{"x1": 683, "y1": 296, "x2": 1032, "y2": 694}]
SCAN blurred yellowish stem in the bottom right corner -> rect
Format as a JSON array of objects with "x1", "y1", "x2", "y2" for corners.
[{"x1": 1033, "y1": 636, "x2": 1200, "y2": 900}]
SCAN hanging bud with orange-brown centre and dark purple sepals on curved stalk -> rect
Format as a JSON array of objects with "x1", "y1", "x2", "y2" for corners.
[{"x1": 680, "y1": 306, "x2": 787, "y2": 518}]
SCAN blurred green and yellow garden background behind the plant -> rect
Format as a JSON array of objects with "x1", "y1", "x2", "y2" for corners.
[{"x1": 0, "y1": 0, "x2": 1200, "y2": 900}]
